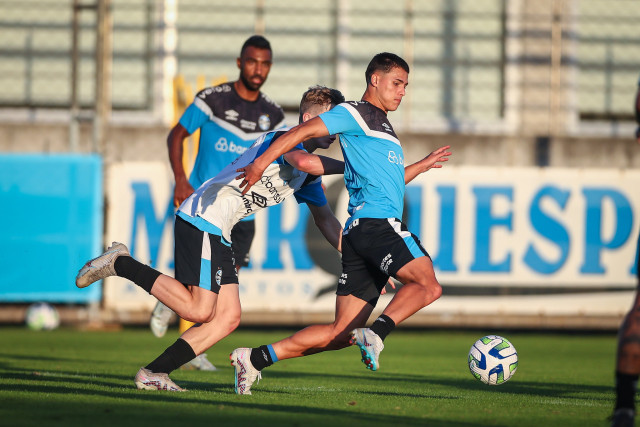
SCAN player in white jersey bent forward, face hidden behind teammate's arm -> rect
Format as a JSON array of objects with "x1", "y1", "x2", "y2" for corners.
[{"x1": 76, "y1": 87, "x2": 344, "y2": 391}]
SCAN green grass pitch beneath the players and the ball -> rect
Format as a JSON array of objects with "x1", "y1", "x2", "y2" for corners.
[{"x1": 0, "y1": 327, "x2": 616, "y2": 427}]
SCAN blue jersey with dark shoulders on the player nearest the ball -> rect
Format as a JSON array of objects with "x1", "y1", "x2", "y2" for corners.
[{"x1": 319, "y1": 101, "x2": 405, "y2": 228}]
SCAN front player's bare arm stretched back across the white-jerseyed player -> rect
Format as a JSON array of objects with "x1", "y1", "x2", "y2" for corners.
[{"x1": 236, "y1": 117, "x2": 329, "y2": 194}]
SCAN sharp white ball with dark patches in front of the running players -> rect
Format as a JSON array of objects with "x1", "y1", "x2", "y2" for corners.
[{"x1": 469, "y1": 335, "x2": 518, "y2": 385}]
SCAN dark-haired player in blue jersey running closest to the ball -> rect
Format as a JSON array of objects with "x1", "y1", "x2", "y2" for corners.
[{"x1": 231, "y1": 53, "x2": 451, "y2": 394}]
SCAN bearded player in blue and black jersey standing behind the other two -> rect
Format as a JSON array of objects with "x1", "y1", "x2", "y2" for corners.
[{"x1": 150, "y1": 35, "x2": 284, "y2": 370}]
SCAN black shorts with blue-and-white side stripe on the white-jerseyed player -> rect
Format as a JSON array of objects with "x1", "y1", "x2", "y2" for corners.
[{"x1": 174, "y1": 216, "x2": 238, "y2": 294}]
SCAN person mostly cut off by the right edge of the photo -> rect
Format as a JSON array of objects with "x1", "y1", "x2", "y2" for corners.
[{"x1": 611, "y1": 81, "x2": 640, "y2": 427}]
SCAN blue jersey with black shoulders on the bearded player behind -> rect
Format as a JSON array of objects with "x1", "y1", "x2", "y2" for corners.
[{"x1": 180, "y1": 83, "x2": 284, "y2": 188}]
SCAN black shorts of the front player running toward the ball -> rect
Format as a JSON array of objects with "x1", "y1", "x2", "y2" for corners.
[{"x1": 336, "y1": 218, "x2": 429, "y2": 306}]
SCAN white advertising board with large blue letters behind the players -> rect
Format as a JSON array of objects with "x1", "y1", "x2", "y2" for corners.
[{"x1": 104, "y1": 162, "x2": 640, "y2": 316}]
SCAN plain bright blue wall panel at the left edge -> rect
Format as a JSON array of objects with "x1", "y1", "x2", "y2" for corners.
[{"x1": 0, "y1": 154, "x2": 104, "y2": 303}]
